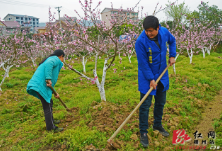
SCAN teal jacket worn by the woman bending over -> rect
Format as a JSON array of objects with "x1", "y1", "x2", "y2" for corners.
[{"x1": 26, "y1": 56, "x2": 63, "y2": 103}]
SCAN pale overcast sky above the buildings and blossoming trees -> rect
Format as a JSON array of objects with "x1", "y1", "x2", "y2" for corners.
[{"x1": 0, "y1": 0, "x2": 222, "y2": 22}]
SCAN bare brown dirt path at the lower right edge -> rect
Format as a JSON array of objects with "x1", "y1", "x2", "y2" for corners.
[{"x1": 185, "y1": 90, "x2": 222, "y2": 151}]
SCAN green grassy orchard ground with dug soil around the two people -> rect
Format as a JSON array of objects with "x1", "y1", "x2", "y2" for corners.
[{"x1": 0, "y1": 53, "x2": 222, "y2": 151}]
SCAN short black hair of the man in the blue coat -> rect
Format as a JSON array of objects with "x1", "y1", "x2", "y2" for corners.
[{"x1": 143, "y1": 16, "x2": 159, "y2": 30}]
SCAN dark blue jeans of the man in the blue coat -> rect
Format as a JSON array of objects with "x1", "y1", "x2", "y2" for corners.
[{"x1": 139, "y1": 82, "x2": 166, "y2": 134}]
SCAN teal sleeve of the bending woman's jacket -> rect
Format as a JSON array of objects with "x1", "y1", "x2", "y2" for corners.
[{"x1": 45, "y1": 59, "x2": 57, "y2": 80}]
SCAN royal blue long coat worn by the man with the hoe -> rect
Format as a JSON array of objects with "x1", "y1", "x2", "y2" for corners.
[{"x1": 135, "y1": 26, "x2": 176, "y2": 95}]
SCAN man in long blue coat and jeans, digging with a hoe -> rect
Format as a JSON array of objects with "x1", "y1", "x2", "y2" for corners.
[{"x1": 135, "y1": 16, "x2": 176, "y2": 147}]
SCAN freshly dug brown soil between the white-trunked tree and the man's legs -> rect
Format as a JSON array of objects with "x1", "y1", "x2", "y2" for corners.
[{"x1": 88, "y1": 102, "x2": 139, "y2": 134}]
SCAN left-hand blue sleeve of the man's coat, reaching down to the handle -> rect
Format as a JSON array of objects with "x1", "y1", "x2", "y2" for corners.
[{"x1": 135, "y1": 41, "x2": 154, "y2": 81}]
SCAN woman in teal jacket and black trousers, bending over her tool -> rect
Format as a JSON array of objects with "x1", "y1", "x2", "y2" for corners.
[{"x1": 27, "y1": 49, "x2": 65, "y2": 132}]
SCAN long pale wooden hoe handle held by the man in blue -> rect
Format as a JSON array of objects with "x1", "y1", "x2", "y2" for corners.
[{"x1": 107, "y1": 64, "x2": 170, "y2": 143}]
